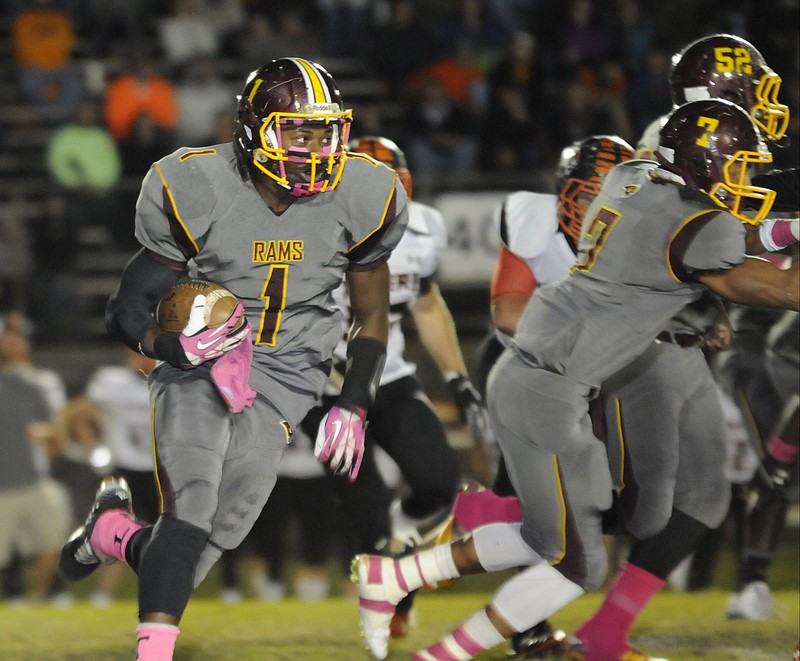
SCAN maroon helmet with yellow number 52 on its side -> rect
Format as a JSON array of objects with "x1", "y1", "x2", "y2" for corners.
[{"x1": 669, "y1": 34, "x2": 789, "y2": 140}]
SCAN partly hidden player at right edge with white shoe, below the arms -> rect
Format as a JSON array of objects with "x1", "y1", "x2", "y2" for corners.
[{"x1": 718, "y1": 304, "x2": 800, "y2": 620}]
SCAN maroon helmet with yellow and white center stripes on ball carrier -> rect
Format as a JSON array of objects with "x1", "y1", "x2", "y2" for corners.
[{"x1": 234, "y1": 57, "x2": 352, "y2": 197}]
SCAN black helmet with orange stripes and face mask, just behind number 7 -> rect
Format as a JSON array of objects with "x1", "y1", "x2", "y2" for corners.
[{"x1": 556, "y1": 135, "x2": 633, "y2": 249}]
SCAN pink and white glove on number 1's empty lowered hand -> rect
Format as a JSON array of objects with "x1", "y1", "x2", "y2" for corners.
[{"x1": 314, "y1": 406, "x2": 367, "y2": 482}]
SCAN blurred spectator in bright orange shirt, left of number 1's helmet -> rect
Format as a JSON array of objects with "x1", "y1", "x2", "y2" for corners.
[{"x1": 104, "y1": 57, "x2": 178, "y2": 142}]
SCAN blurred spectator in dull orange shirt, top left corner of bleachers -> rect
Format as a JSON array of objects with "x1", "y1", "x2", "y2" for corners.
[{"x1": 11, "y1": 0, "x2": 84, "y2": 121}]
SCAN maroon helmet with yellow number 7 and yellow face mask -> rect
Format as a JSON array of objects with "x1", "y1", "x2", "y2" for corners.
[{"x1": 655, "y1": 99, "x2": 775, "y2": 224}]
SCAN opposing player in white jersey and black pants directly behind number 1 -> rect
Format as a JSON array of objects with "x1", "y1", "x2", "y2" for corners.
[{"x1": 304, "y1": 136, "x2": 489, "y2": 637}]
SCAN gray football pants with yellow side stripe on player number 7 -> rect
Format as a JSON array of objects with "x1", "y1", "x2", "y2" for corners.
[{"x1": 487, "y1": 350, "x2": 611, "y2": 592}]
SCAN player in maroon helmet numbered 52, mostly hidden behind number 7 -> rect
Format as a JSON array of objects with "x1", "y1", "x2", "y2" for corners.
[{"x1": 570, "y1": 35, "x2": 797, "y2": 661}]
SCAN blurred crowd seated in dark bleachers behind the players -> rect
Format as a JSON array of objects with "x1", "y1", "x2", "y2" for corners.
[{"x1": 0, "y1": 0, "x2": 800, "y2": 341}]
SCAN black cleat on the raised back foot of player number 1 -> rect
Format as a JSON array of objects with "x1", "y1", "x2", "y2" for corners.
[{"x1": 58, "y1": 477, "x2": 133, "y2": 581}]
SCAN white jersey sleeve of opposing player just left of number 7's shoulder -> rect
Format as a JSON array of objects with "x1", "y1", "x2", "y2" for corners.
[{"x1": 497, "y1": 191, "x2": 558, "y2": 259}]
